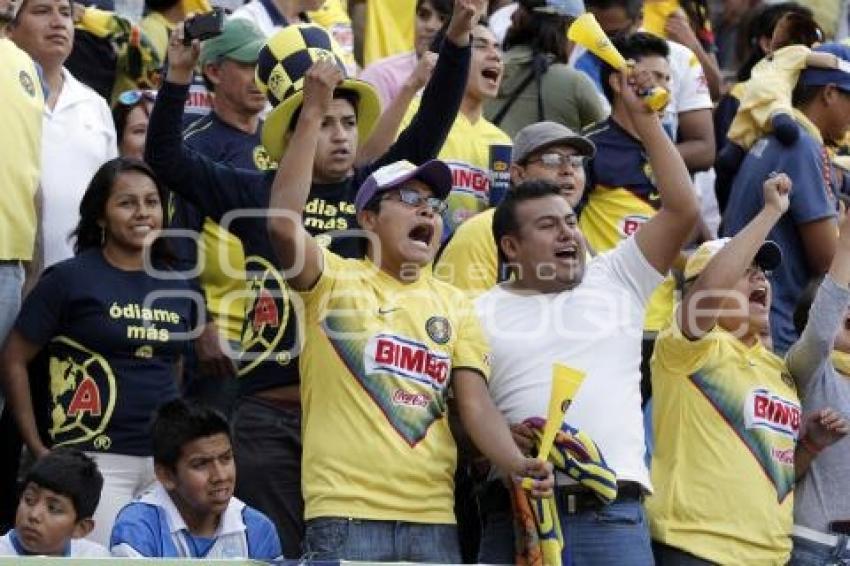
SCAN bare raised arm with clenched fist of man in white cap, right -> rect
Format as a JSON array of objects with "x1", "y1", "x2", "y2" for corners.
[{"x1": 677, "y1": 174, "x2": 791, "y2": 340}]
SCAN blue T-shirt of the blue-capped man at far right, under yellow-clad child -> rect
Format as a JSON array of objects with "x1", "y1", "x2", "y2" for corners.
[{"x1": 721, "y1": 128, "x2": 838, "y2": 354}]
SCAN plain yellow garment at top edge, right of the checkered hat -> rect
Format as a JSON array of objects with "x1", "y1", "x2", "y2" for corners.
[{"x1": 363, "y1": 0, "x2": 416, "y2": 68}]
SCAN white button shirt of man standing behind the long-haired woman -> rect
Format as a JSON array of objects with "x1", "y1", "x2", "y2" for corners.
[{"x1": 41, "y1": 69, "x2": 118, "y2": 267}]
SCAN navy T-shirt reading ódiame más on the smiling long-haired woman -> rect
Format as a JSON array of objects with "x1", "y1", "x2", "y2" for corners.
[{"x1": 15, "y1": 249, "x2": 195, "y2": 456}]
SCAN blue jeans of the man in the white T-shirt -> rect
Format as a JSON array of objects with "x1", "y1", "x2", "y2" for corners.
[{"x1": 478, "y1": 501, "x2": 655, "y2": 566}]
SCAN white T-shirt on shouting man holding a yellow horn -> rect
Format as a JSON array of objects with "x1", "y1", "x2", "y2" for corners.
[{"x1": 475, "y1": 238, "x2": 664, "y2": 489}]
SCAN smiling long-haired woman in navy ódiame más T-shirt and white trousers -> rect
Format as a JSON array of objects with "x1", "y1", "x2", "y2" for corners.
[{"x1": 2, "y1": 158, "x2": 196, "y2": 544}]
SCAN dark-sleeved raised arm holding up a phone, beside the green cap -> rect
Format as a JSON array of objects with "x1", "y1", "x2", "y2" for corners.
[{"x1": 145, "y1": 25, "x2": 267, "y2": 221}]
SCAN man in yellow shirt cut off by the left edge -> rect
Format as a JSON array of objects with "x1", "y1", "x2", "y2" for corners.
[{"x1": 0, "y1": 0, "x2": 44, "y2": 413}]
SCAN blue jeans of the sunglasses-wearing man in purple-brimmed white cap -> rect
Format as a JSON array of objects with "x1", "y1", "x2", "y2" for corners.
[{"x1": 304, "y1": 517, "x2": 461, "y2": 564}]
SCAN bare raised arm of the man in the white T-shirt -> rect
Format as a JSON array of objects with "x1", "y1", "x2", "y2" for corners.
[{"x1": 618, "y1": 69, "x2": 699, "y2": 273}]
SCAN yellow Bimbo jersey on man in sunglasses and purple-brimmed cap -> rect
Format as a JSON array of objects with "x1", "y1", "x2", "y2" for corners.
[{"x1": 299, "y1": 250, "x2": 489, "y2": 524}]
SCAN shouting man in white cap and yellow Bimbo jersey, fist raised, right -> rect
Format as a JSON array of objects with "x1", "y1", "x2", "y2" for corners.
[{"x1": 647, "y1": 173, "x2": 838, "y2": 565}]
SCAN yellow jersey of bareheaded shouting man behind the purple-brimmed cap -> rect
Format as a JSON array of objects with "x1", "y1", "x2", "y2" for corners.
[{"x1": 401, "y1": 100, "x2": 511, "y2": 239}]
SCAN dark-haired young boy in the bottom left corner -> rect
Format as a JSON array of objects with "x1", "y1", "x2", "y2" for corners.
[{"x1": 0, "y1": 447, "x2": 109, "y2": 558}]
